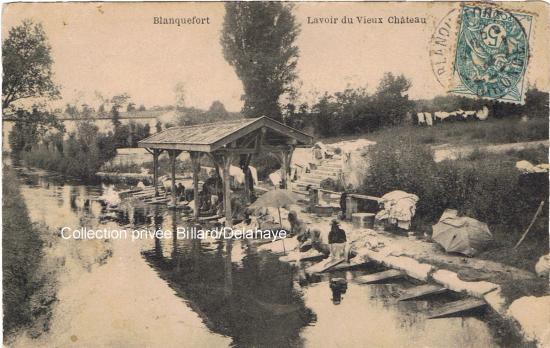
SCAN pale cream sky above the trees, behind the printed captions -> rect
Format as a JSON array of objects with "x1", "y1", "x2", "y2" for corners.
[{"x1": 2, "y1": 2, "x2": 550, "y2": 111}]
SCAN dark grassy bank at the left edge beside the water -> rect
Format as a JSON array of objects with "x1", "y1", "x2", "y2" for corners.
[{"x1": 2, "y1": 166, "x2": 55, "y2": 340}]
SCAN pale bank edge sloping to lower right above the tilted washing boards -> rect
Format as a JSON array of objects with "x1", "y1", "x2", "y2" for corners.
[{"x1": 274, "y1": 209, "x2": 550, "y2": 346}]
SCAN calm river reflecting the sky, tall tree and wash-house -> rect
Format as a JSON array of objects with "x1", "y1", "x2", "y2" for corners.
[{"x1": 10, "y1": 168, "x2": 520, "y2": 347}]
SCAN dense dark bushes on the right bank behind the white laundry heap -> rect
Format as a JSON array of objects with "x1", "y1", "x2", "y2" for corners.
[{"x1": 362, "y1": 138, "x2": 548, "y2": 235}]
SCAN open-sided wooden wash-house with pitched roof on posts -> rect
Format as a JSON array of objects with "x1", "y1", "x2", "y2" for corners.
[{"x1": 138, "y1": 116, "x2": 313, "y2": 226}]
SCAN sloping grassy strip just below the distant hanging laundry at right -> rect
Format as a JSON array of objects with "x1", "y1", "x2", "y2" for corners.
[{"x1": 326, "y1": 118, "x2": 548, "y2": 145}]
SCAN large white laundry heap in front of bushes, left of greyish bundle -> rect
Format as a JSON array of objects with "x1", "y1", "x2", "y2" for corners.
[{"x1": 375, "y1": 190, "x2": 418, "y2": 230}]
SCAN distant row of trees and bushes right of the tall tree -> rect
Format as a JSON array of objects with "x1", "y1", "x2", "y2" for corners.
[{"x1": 284, "y1": 81, "x2": 549, "y2": 137}]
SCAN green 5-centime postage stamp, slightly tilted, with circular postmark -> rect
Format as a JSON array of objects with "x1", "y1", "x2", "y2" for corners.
[{"x1": 450, "y1": 5, "x2": 533, "y2": 103}]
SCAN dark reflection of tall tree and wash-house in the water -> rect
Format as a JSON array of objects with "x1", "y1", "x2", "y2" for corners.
[{"x1": 143, "y1": 209, "x2": 314, "y2": 346}]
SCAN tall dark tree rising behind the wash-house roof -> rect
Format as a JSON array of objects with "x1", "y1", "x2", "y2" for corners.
[{"x1": 221, "y1": 2, "x2": 299, "y2": 120}]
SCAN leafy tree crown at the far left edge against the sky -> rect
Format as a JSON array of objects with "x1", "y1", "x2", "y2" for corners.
[{"x1": 2, "y1": 19, "x2": 59, "y2": 110}]
